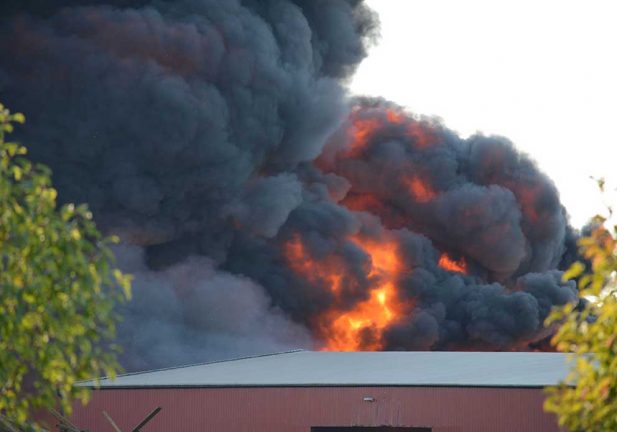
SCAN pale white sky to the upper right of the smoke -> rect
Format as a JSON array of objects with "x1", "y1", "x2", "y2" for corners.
[{"x1": 350, "y1": 0, "x2": 617, "y2": 227}]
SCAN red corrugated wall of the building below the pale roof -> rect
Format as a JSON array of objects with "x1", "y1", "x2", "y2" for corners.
[{"x1": 73, "y1": 387, "x2": 559, "y2": 432}]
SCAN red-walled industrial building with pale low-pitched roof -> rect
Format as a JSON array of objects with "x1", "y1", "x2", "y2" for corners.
[{"x1": 72, "y1": 351, "x2": 567, "y2": 432}]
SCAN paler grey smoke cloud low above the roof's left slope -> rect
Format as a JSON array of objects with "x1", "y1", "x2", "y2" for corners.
[{"x1": 115, "y1": 246, "x2": 314, "y2": 370}]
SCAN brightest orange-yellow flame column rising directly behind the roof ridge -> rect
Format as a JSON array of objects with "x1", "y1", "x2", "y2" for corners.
[{"x1": 323, "y1": 238, "x2": 411, "y2": 351}]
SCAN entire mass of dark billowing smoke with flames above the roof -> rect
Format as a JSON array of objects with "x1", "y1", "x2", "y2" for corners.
[{"x1": 0, "y1": 0, "x2": 576, "y2": 370}]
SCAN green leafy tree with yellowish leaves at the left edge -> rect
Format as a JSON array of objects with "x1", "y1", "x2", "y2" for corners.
[{"x1": 0, "y1": 104, "x2": 130, "y2": 430}]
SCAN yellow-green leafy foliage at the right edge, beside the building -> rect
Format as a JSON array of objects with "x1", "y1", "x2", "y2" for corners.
[{"x1": 545, "y1": 187, "x2": 617, "y2": 432}]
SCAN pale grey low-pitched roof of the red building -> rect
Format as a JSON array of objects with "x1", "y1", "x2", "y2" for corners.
[{"x1": 80, "y1": 351, "x2": 567, "y2": 388}]
